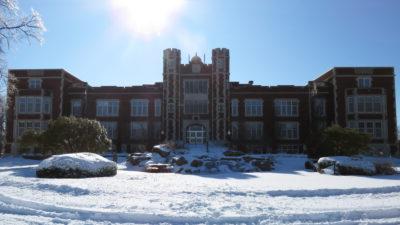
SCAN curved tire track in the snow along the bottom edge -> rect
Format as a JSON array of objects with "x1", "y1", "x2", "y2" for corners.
[{"x1": 0, "y1": 194, "x2": 400, "y2": 224}]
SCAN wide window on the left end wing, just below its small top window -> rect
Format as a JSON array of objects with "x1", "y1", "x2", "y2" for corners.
[{"x1": 17, "y1": 96, "x2": 52, "y2": 114}]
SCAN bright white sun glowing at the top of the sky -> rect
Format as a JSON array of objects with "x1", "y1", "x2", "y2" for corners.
[{"x1": 111, "y1": 0, "x2": 184, "y2": 37}]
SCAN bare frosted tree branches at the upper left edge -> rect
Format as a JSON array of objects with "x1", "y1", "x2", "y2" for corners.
[{"x1": 0, "y1": 0, "x2": 46, "y2": 92}]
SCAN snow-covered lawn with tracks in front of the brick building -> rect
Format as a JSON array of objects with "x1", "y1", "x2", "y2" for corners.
[{"x1": 0, "y1": 152, "x2": 400, "y2": 224}]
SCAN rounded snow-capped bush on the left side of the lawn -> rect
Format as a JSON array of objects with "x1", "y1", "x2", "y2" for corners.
[{"x1": 36, "y1": 152, "x2": 117, "y2": 178}]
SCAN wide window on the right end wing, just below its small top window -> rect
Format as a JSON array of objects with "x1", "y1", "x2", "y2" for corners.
[{"x1": 347, "y1": 95, "x2": 384, "y2": 113}]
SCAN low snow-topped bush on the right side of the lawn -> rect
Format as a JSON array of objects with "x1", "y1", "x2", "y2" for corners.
[{"x1": 318, "y1": 156, "x2": 376, "y2": 175}]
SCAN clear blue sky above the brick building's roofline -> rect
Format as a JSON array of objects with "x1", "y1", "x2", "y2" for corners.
[{"x1": 7, "y1": 0, "x2": 400, "y2": 111}]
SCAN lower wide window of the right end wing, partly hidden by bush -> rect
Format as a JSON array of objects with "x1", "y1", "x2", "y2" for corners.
[{"x1": 348, "y1": 120, "x2": 384, "y2": 139}]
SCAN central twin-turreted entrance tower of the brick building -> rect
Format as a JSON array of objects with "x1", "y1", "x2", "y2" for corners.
[{"x1": 163, "y1": 48, "x2": 230, "y2": 144}]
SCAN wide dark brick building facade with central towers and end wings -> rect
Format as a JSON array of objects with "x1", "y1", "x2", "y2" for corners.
[{"x1": 6, "y1": 48, "x2": 397, "y2": 152}]
